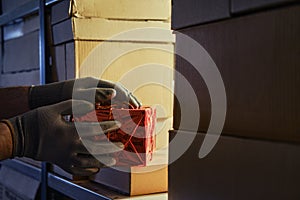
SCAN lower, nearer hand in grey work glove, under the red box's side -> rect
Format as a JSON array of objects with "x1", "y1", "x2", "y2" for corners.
[{"x1": 3, "y1": 100, "x2": 123, "y2": 176}]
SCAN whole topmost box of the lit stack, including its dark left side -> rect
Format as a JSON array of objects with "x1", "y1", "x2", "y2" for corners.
[{"x1": 51, "y1": 0, "x2": 171, "y2": 24}]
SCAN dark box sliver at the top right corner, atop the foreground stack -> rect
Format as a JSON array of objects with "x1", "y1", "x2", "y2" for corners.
[{"x1": 231, "y1": 0, "x2": 297, "y2": 13}]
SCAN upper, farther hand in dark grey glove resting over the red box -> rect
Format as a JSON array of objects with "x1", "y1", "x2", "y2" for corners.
[{"x1": 29, "y1": 77, "x2": 141, "y2": 109}]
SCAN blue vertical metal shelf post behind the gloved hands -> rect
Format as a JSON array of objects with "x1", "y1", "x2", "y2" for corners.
[{"x1": 38, "y1": 0, "x2": 48, "y2": 200}]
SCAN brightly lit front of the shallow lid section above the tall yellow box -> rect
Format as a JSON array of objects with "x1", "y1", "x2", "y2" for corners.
[{"x1": 72, "y1": 17, "x2": 175, "y2": 42}]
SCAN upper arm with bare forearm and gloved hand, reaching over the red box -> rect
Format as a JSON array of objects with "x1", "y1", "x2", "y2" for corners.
[{"x1": 0, "y1": 77, "x2": 141, "y2": 119}]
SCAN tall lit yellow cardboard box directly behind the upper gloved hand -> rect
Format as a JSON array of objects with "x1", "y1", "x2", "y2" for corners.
[{"x1": 75, "y1": 41, "x2": 174, "y2": 118}]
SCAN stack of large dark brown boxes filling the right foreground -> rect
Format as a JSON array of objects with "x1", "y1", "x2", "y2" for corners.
[{"x1": 169, "y1": 0, "x2": 300, "y2": 200}]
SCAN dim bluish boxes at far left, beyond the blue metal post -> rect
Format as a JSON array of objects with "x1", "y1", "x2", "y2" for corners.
[{"x1": 0, "y1": 0, "x2": 39, "y2": 86}]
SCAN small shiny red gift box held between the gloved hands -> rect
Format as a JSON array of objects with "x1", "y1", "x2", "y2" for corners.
[{"x1": 75, "y1": 106, "x2": 156, "y2": 166}]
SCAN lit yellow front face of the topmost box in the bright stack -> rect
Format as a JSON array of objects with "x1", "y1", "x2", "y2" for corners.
[{"x1": 72, "y1": 0, "x2": 171, "y2": 20}]
